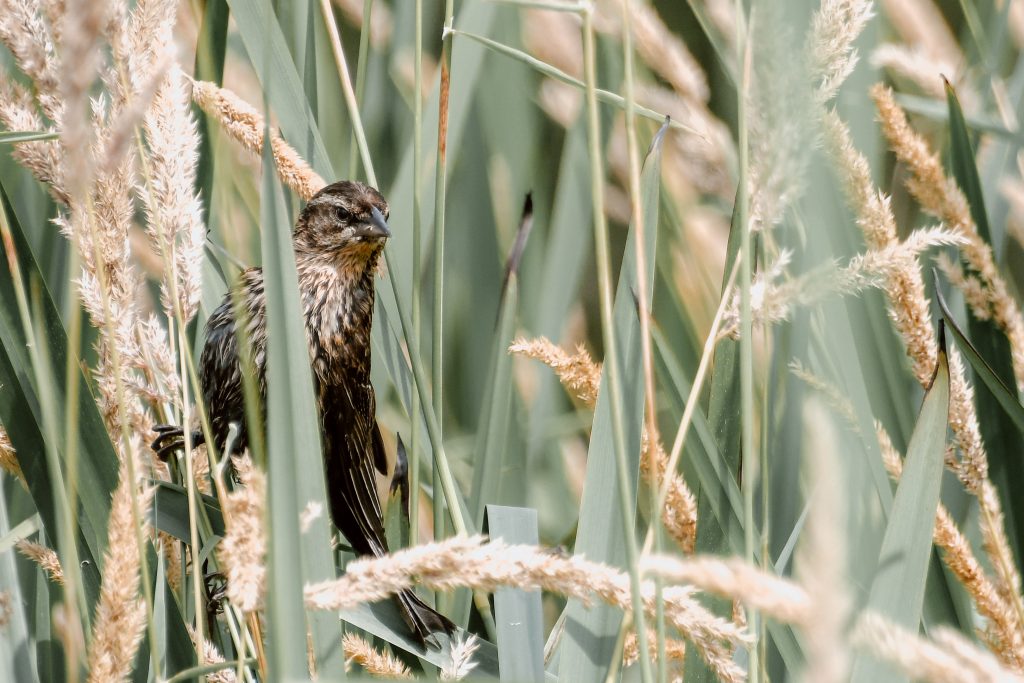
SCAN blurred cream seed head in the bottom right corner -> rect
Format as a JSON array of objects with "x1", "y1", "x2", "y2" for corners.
[{"x1": 852, "y1": 612, "x2": 1024, "y2": 683}]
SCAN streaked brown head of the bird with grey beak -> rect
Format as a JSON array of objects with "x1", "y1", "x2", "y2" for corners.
[{"x1": 295, "y1": 180, "x2": 391, "y2": 267}]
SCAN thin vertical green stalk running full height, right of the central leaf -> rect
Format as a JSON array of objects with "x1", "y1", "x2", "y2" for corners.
[{"x1": 735, "y1": 0, "x2": 761, "y2": 683}]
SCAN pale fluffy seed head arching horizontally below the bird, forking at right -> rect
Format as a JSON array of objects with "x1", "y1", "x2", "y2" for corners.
[{"x1": 305, "y1": 537, "x2": 774, "y2": 681}]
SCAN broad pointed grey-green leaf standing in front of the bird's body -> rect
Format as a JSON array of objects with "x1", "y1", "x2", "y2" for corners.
[{"x1": 261, "y1": 118, "x2": 344, "y2": 680}]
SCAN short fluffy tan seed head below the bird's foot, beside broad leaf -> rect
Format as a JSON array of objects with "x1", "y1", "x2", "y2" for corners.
[{"x1": 217, "y1": 455, "x2": 266, "y2": 613}]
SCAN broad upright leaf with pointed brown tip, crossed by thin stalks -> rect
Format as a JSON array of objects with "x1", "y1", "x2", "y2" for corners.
[{"x1": 558, "y1": 121, "x2": 665, "y2": 681}]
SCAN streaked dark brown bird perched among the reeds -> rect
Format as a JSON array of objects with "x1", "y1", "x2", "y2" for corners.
[{"x1": 153, "y1": 180, "x2": 455, "y2": 647}]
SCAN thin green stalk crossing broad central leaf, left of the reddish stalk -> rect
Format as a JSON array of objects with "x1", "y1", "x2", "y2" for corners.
[{"x1": 583, "y1": 10, "x2": 653, "y2": 683}]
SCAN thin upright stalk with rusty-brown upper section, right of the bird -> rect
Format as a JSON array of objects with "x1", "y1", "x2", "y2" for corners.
[{"x1": 430, "y1": 0, "x2": 458, "y2": 565}]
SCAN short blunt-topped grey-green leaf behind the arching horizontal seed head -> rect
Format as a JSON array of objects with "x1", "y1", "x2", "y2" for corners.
[{"x1": 485, "y1": 505, "x2": 544, "y2": 683}]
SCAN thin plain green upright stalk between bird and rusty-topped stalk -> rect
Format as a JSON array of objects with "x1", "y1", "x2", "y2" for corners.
[{"x1": 409, "y1": 0, "x2": 423, "y2": 545}]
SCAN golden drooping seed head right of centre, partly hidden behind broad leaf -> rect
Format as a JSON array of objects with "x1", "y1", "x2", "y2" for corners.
[{"x1": 509, "y1": 337, "x2": 697, "y2": 553}]
